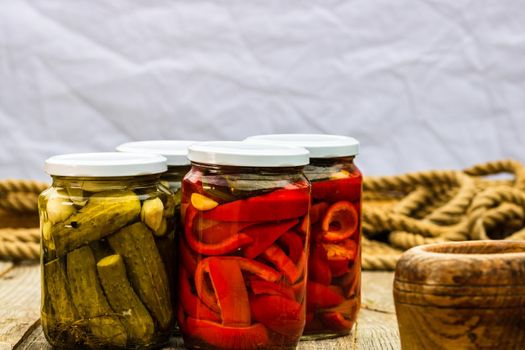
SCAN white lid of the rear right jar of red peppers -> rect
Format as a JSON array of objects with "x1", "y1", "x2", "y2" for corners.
[{"x1": 245, "y1": 134, "x2": 359, "y2": 158}]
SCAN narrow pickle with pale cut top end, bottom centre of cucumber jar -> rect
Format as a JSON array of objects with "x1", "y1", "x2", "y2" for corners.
[{"x1": 97, "y1": 254, "x2": 155, "y2": 345}]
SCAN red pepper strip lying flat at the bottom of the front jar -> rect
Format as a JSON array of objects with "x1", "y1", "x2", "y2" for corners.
[{"x1": 186, "y1": 317, "x2": 270, "y2": 350}]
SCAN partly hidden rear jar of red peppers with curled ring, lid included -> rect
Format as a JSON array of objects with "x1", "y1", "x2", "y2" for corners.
[{"x1": 247, "y1": 134, "x2": 362, "y2": 339}]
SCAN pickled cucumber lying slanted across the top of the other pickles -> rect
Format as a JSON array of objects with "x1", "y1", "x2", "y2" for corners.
[{"x1": 52, "y1": 191, "x2": 141, "y2": 256}]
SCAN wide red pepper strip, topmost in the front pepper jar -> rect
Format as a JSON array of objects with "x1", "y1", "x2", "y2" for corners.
[{"x1": 202, "y1": 188, "x2": 310, "y2": 222}]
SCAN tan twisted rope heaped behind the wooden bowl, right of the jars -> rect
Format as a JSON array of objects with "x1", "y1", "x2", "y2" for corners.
[{"x1": 362, "y1": 160, "x2": 525, "y2": 270}]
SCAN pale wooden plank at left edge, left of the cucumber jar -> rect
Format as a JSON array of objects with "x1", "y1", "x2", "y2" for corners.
[{"x1": 0, "y1": 264, "x2": 40, "y2": 350}]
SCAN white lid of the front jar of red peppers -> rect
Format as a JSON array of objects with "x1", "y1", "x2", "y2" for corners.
[{"x1": 188, "y1": 141, "x2": 309, "y2": 167}]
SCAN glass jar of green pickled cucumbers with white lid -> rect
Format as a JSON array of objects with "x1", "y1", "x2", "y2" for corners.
[{"x1": 38, "y1": 153, "x2": 175, "y2": 349}]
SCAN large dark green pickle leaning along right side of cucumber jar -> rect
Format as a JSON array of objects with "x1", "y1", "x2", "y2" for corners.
[{"x1": 108, "y1": 222, "x2": 173, "y2": 330}]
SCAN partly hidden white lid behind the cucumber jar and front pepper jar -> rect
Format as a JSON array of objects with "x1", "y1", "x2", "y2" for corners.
[{"x1": 117, "y1": 140, "x2": 196, "y2": 166}]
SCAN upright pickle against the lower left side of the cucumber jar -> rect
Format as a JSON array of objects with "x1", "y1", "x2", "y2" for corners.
[{"x1": 42, "y1": 259, "x2": 78, "y2": 336}]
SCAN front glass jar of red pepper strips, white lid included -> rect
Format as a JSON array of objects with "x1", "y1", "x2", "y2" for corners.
[{"x1": 177, "y1": 142, "x2": 310, "y2": 349}]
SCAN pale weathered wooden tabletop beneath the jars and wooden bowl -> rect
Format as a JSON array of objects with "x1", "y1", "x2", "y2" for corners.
[{"x1": 0, "y1": 261, "x2": 400, "y2": 350}]
